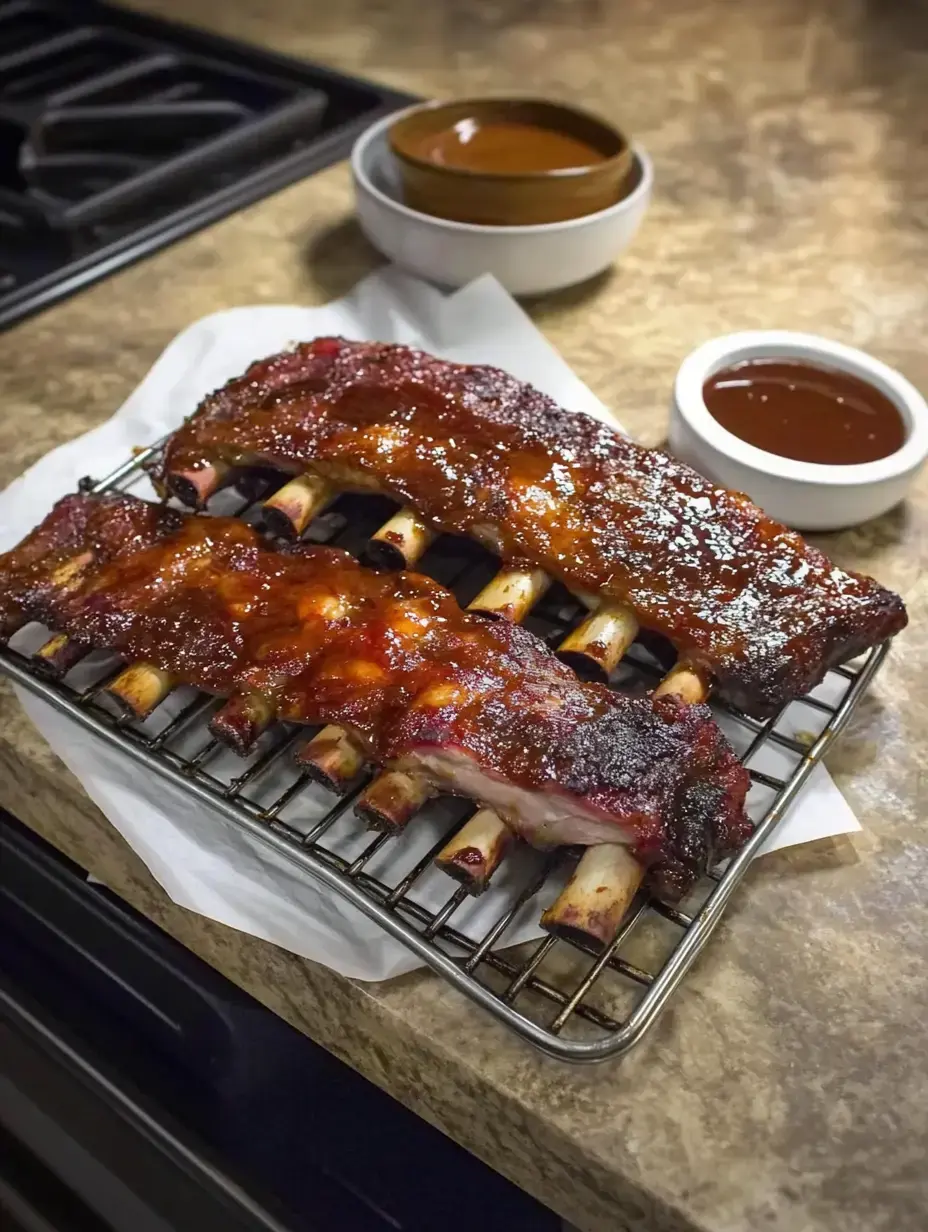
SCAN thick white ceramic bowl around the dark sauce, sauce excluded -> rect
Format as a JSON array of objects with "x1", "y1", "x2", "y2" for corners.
[{"x1": 669, "y1": 329, "x2": 928, "y2": 531}]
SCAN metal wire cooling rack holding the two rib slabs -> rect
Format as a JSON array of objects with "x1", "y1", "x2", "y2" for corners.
[{"x1": 0, "y1": 446, "x2": 889, "y2": 1062}]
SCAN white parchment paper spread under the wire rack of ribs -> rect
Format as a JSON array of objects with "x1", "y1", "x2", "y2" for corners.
[{"x1": 0, "y1": 269, "x2": 859, "y2": 979}]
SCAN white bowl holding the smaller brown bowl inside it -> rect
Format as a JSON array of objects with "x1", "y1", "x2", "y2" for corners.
[{"x1": 351, "y1": 105, "x2": 653, "y2": 296}]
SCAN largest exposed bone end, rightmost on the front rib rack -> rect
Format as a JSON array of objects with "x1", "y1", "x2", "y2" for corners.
[{"x1": 541, "y1": 844, "x2": 643, "y2": 949}]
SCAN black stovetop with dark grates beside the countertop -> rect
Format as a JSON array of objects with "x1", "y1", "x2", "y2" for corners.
[{"x1": 0, "y1": 0, "x2": 408, "y2": 326}]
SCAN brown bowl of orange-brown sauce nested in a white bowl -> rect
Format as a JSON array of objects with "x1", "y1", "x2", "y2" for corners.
[{"x1": 389, "y1": 99, "x2": 632, "y2": 227}]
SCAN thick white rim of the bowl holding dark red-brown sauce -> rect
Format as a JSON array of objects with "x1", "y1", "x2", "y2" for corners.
[{"x1": 673, "y1": 329, "x2": 928, "y2": 488}]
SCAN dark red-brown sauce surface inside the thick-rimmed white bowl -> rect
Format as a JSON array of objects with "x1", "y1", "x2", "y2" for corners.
[{"x1": 702, "y1": 360, "x2": 906, "y2": 466}]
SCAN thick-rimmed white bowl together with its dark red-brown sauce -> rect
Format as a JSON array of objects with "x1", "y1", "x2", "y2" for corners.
[{"x1": 669, "y1": 330, "x2": 928, "y2": 531}]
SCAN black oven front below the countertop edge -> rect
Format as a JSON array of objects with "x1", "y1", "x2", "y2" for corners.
[{"x1": 0, "y1": 811, "x2": 561, "y2": 1232}]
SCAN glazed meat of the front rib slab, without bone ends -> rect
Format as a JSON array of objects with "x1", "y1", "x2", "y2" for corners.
[{"x1": 0, "y1": 495, "x2": 751, "y2": 898}]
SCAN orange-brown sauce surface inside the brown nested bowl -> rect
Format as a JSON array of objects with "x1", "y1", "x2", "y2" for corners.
[{"x1": 409, "y1": 117, "x2": 606, "y2": 175}]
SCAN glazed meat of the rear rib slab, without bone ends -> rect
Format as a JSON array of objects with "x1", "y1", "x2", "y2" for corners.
[{"x1": 159, "y1": 338, "x2": 906, "y2": 717}]
